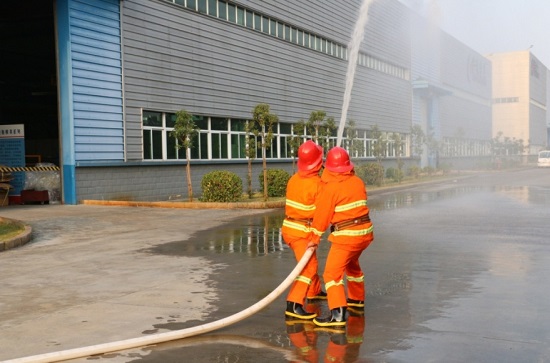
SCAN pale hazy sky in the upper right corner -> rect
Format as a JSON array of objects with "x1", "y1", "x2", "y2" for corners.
[{"x1": 399, "y1": 0, "x2": 550, "y2": 68}]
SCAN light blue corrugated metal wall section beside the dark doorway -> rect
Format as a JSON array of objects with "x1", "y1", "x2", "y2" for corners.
[{"x1": 69, "y1": 0, "x2": 124, "y2": 164}]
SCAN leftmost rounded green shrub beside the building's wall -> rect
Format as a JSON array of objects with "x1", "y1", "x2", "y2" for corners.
[{"x1": 200, "y1": 170, "x2": 243, "y2": 203}]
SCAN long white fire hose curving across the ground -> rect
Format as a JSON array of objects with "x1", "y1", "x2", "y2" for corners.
[{"x1": 2, "y1": 248, "x2": 315, "y2": 363}]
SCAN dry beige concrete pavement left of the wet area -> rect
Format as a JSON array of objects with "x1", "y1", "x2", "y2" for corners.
[{"x1": 0, "y1": 205, "x2": 270, "y2": 361}]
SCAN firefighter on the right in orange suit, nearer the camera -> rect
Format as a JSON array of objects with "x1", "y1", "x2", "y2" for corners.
[{"x1": 308, "y1": 146, "x2": 373, "y2": 328}]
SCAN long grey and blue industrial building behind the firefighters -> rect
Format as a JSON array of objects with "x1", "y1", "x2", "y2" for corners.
[{"x1": 0, "y1": 0, "x2": 516, "y2": 204}]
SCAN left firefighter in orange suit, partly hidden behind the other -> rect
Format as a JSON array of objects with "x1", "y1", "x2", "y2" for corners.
[{"x1": 282, "y1": 141, "x2": 326, "y2": 319}]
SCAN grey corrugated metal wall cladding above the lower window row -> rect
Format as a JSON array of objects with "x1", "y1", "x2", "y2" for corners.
[{"x1": 122, "y1": 0, "x2": 411, "y2": 161}]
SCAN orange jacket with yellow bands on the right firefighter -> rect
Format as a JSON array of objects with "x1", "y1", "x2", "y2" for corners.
[{"x1": 310, "y1": 169, "x2": 373, "y2": 246}]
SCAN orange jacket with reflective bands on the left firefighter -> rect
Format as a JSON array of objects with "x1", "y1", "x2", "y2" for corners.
[{"x1": 282, "y1": 170, "x2": 321, "y2": 241}]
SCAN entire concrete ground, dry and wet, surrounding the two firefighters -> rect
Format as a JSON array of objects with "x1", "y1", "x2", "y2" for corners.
[{"x1": 0, "y1": 169, "x2": 550, "y2": 363}]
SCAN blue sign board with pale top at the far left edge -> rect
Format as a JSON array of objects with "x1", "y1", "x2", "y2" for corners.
[{"x1": 0, "y1": 124, "x2": 25, "y2": 199}]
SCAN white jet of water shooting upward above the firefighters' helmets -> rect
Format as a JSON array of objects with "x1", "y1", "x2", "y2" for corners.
[{"x1": 336, "y1": 0, "x2": 373, "y2": 146}]
